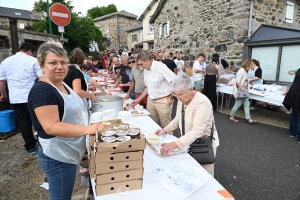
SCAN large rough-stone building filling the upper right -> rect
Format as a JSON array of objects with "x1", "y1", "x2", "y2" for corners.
[{"x1": 150, "y1": 0, "x2": 300, "y2": 82}]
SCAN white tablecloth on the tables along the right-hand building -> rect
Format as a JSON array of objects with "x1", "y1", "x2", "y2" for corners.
[{"x1": 217, "y1": 85, "x2": 284, "y2": 106}]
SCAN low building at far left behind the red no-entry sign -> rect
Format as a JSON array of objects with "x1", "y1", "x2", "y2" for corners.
[{"x1": 0, "y1": 7, "x2": 59, "y2": 63}]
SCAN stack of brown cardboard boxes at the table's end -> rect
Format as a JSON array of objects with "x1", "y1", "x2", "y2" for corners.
[{"x1": 90, "y1": 121, "x2": 146, "y2": 196}]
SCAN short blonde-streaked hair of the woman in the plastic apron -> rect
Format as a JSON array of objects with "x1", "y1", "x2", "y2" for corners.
[{"x1": 36, "y1": 40, "x2": 68, "y2": 65}]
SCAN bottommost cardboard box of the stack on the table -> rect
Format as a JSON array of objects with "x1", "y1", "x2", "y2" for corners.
[{"x1": 96, "y1": 179, "x2": 143, "y2": 196}]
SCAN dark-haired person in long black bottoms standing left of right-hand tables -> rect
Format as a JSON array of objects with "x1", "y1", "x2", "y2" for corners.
[{"x1": 203, "y1": 57, "x2": 221, "y2": 111}]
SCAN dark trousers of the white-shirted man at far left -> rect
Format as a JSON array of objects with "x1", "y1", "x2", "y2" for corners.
[{"x1": 11, "y1": 103, "x2": 37, "y2": 151}]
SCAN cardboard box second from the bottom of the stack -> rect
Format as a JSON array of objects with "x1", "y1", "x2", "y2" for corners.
[{"x1": 96, "y1": 168, "x2": 144, "y2": 185}]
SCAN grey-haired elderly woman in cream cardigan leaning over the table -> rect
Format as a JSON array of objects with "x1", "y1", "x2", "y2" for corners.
[{"x1": 155, "y1": 73, "x2": 219, "y2": 176}]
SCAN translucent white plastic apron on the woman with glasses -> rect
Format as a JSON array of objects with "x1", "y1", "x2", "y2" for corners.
[{"x1": 39, "y1": 79, "x2": 85, "y2": 165}]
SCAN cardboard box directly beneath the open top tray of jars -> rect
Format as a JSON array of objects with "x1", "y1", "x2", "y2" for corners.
[{"x1": 94, "y1": 151, "x2": 144, "y2": 163}]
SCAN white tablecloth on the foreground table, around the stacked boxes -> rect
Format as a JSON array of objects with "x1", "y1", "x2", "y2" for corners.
[{"x1": 91, "y1": 116, "x2": 233, "y2": 200}]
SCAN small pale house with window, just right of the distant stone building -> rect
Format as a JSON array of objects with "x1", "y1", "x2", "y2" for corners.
[{"x1": 127, "y1": 23, "x2": 143, "y2": 49}]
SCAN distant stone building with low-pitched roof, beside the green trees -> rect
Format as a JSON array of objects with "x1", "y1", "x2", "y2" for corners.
[{"x1": 94, "y1": 10, "x2": 139, "y2": 48}]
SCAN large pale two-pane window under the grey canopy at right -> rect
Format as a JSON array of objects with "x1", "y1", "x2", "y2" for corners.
[{"x1": 251, "y1": 45, "x2": 300, "y2": 83}]
